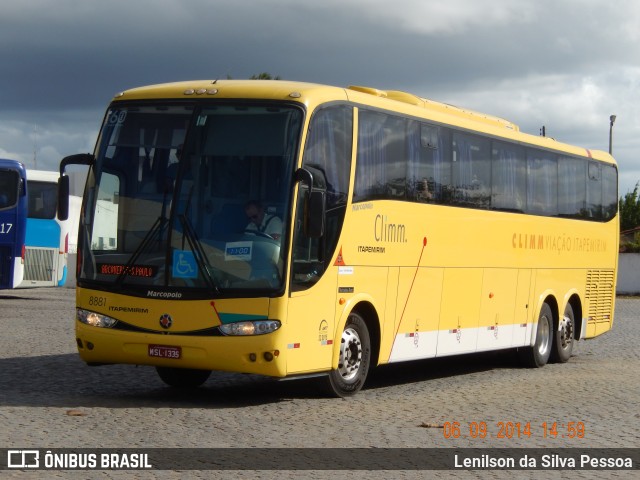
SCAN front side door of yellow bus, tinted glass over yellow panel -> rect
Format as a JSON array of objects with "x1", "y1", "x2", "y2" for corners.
[{"x1": 286, "y1": 105, "x2": 353, "y2": 374}]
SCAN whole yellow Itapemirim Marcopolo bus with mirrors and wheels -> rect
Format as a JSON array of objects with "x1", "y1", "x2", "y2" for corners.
[{"x1": 59, "y1": 80, "x2": 619, "y2": 397}]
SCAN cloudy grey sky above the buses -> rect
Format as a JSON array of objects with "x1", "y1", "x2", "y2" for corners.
[{"x1": 0, "y1": 0, "x2": 640, "y2": 195}]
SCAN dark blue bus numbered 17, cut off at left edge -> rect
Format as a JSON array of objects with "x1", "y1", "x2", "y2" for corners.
[{"x1": 0, "y1": 159, "x2": 27, "y2": 289}]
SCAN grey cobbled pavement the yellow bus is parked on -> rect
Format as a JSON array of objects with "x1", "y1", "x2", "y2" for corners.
[{"x1": 0, "y1": 289, "x2": 640, "y2": 478}]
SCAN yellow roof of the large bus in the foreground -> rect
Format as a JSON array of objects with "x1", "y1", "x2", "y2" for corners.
[{"x1": 114, "y1": 80, "x2": 615, "y2": 164}]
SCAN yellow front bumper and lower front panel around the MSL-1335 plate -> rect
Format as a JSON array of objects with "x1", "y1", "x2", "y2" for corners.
[{"x1": 76, "y1": 288, "x2": 287, "y2": 377}]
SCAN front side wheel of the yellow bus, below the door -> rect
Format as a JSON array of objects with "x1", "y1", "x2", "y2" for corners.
[{"x1": 328, "y1": 312, "x2": 371, "y2": 398}]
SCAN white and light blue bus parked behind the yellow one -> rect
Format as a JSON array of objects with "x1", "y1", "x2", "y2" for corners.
[{"x1": 19, "y1": 170, "x2": 69, "y2": 287}]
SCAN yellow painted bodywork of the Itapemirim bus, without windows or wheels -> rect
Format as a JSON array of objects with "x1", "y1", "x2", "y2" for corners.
[{"x1": 76, "y1": 80, "x2": 619, "y2": 377}]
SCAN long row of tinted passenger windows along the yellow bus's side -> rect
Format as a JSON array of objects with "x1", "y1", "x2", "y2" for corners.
[{"x1": 353, "y1": 110, "x2": 618, "y2": 221}]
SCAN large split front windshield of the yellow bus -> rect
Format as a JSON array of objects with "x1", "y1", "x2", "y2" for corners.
[{"x1": 78, "y1": 102, "x2": 302, "y2": 295}]
